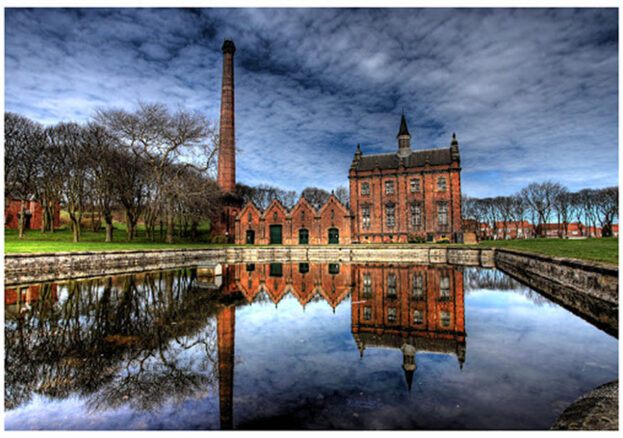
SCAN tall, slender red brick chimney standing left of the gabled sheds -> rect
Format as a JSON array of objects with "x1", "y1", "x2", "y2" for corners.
[{"x1": 217, "y1": 40, "x2": 236, "y2": 193}]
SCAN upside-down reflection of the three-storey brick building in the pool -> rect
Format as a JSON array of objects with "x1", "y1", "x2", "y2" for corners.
[{"x1": 351, "y1": 264, "x2": 465, "y2": 390}]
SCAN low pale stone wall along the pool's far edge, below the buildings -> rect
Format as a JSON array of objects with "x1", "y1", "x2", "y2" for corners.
[{"x1": 4, "y1": 245, "x2": 494, "y2": 285}]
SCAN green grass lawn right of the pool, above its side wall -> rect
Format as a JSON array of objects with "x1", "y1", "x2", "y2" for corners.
[{"x1": 478, "y1": 237, "x2": 619, "y2": 265}]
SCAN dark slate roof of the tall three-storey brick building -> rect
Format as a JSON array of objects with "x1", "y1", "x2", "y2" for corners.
[{"x1": 353, "y1": 148, "x2": 452, "y2": 172}]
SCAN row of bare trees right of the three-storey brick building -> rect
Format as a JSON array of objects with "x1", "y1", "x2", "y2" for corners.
[{"x1": 461, "y1": 181, "x2": 619, "y2": 239}]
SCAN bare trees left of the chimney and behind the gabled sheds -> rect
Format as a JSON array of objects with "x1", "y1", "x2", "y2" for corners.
[{"x1": 4, "y1": 102, "x2": 348, "y2": 243}]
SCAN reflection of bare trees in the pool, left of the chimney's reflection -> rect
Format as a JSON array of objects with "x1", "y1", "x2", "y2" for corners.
[{"x1": 5, "y1": 269, "x2": 232, "y2": 411}]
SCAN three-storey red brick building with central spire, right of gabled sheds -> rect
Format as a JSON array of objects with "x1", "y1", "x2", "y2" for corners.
[{"x1": 348, "y1": 114, "x2": 462, "y2": 242}]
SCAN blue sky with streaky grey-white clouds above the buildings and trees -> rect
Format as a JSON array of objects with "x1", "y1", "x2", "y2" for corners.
[{"x1": 5, "y1": 9, "x2": 618, "y2": 196}]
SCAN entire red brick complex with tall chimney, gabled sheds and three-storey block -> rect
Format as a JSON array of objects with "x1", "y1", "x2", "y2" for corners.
[{"x1": 218, "y1": 37, "x2": 463, "y2": 244}]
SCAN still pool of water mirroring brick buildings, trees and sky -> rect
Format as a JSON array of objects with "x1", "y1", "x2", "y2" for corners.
[{"x1": 5, "y1": 263, "x2": 618, "y2": 430}]
